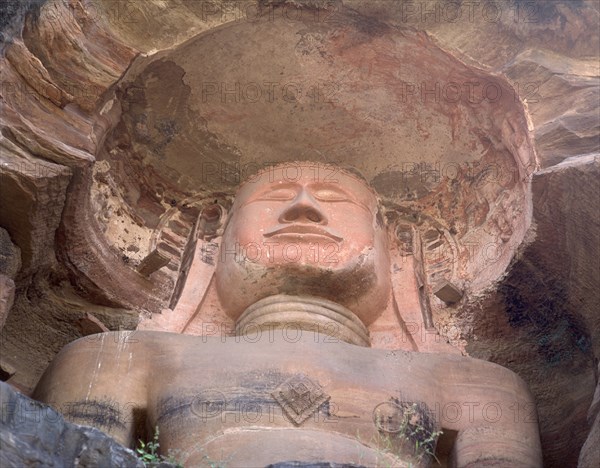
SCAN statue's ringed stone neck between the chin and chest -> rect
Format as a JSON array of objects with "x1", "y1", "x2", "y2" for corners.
[{"x1": 235, "y1": 294, "x2": 370, "y2": 347}]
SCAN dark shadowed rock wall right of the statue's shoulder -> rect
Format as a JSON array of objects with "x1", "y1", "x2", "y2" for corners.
[{"x1": 467, "y1": 156, "x2": 600, "y2": 466}]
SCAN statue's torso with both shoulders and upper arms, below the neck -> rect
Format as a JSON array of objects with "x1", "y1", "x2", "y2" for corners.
[{"x1": 37, "y1": 332, "x2": 537, "y2": 466}]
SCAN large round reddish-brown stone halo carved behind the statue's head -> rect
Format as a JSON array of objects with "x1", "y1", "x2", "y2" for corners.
[{"x1": 88, "y1": 3, "x2": 536, "y2": 349}]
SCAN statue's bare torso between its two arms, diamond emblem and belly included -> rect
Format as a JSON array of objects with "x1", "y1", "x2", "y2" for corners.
[{"x1": 141, "y1": 331, "x2": 439, "y2": 466}]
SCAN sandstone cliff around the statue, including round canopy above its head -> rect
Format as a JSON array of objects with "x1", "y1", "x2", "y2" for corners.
[{"x1": 0, "y1": 0, "x2": 600, "y2": 466}]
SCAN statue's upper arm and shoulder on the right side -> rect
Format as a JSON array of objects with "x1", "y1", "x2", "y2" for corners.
[{"x1": 440, "y1": 360, "x2": 542, "y2": 468}]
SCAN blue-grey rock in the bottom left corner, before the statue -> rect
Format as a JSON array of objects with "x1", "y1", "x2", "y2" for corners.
[{"x1": 0, "y1": 382, "x2": 144, "y2": 468}]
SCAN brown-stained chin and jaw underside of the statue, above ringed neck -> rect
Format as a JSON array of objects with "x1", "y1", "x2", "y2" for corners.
[{"x1": 216, "y1": 255, "x2": 389, "y2": 325}]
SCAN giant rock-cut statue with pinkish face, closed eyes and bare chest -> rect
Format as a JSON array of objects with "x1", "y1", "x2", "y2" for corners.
[{"x1": 35, "y1": 162, "x2": 541, "y2": 467}]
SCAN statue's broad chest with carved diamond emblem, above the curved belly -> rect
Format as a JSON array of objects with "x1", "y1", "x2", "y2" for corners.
[{"x1": 150, "y1": 342, "x2": 431, "y2": 456}]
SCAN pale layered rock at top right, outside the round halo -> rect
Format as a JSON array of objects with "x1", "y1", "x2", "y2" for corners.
[{"x1": 345, "y1": 0, "x2": 600, "y2": 167}]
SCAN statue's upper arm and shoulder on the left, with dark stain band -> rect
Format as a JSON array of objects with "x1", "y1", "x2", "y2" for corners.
[{"x1": 33, "y1": 332, "x2": 148, "y2": 446}]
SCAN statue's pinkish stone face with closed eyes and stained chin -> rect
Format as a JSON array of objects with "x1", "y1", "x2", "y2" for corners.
[{"x1": 216, "y1": 163, "x2": 390, "y2": 325}]
